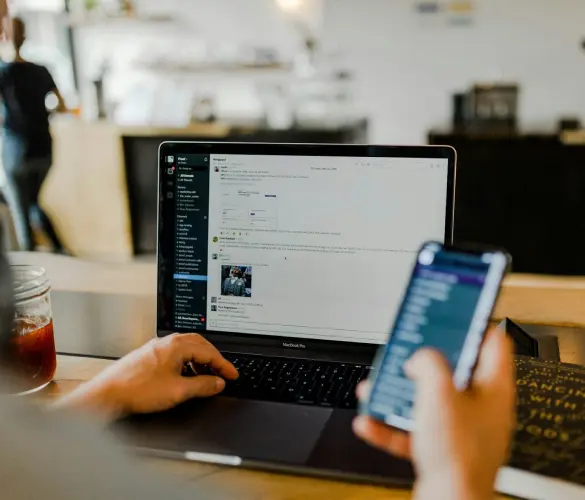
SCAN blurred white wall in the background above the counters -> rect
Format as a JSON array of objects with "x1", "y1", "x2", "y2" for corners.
[{"x1": 78, "y1": 0, "x2": 585, "y2": 143}]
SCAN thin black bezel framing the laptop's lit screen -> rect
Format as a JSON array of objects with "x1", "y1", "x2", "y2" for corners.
[{"x1": 157, "y1": 141, "x2": 457, "y2": 358}]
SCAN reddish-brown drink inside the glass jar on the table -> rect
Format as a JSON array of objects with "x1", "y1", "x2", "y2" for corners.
[{"x1": 12, "y1": 318, "x2": 57, "y2": 392}]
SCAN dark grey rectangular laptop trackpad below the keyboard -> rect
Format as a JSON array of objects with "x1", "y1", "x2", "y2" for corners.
[{"x1": 186, "y1": 397, "x2": 332, "y2": 464}]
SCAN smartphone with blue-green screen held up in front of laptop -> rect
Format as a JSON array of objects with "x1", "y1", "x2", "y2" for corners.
[{"x1": 360, "y1": 242, "x2": 510, "y2": 431}]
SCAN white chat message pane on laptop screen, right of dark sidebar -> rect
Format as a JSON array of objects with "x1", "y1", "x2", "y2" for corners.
[{"x1": 207, "y1": 155, "x2": 448, "y2": 344}]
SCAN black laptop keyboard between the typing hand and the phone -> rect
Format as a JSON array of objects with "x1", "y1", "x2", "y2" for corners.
[{"x1": 223, "y1": 353, "x2": 371, "y2": 409}]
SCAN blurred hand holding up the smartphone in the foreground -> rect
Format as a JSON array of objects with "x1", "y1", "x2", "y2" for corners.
[{"x1": 354, "y1": 331, "x2": 515, "y2": 500}]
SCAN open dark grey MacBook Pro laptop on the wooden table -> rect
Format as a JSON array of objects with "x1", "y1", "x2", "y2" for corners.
[{"x1": 112, "y1": 142, "x2": 456, "y2": 485}]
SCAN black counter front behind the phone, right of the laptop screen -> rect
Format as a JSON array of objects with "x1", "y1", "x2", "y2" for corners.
[{"x1": 429, "y1": 133, "x2": 585, "y2": 275}]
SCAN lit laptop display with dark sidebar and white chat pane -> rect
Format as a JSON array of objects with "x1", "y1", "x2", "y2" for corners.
[{"x1": 158, "y1": 143, "x2": 453, "y2": 344}]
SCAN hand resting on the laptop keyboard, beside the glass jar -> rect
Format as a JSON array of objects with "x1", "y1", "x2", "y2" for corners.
[{"x1": 55, "y1": 334, "x2": 238, "y2": 420}]
